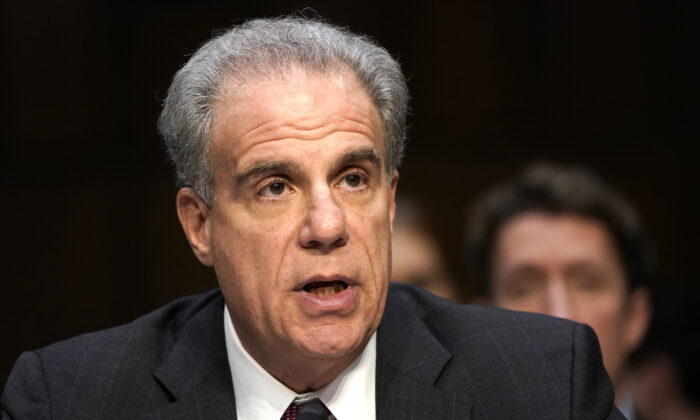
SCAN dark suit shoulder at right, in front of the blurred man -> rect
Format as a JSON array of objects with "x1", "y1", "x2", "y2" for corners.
[{"x1": 385, "y1": 285, "x2": 614, "y2": 419}]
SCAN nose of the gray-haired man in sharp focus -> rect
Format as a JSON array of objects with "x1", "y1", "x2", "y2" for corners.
[{"x1": 299, "y1": 187, "x2": 350, "y2": 252}]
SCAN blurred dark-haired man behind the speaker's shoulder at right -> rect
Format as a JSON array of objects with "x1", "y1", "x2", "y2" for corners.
[{"x1": 469, "y1": 164, "x2": 651, "y2": 416}]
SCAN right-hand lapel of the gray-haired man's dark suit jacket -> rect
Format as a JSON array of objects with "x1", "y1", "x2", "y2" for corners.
[{"x1": 376, "y1": 292, "x2": 472, "y2": 420}]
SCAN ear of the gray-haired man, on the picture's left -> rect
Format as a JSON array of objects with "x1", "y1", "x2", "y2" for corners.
[{"x1": 176, "y1": 188, "x2": 213, "y2": 266}]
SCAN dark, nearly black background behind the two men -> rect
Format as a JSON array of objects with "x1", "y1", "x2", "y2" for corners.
[{"x1": 0, "y1": 0, "x2": 700, "y2": 386}]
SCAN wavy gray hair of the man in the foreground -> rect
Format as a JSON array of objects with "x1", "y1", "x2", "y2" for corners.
[{"x1": 158, "y1": 16, "x2": 408, "y2": 205}]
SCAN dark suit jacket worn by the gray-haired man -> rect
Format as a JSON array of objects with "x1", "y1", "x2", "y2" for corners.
[{"x1": 2, "y1": 285, "x2": 623, "y2": 420}]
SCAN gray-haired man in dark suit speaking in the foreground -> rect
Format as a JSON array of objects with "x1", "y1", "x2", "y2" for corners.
[{"x1": 3, "y1": 18, "x2": 620, "y2": 420}]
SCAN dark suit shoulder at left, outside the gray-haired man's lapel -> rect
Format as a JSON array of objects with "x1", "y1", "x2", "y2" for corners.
[{"x1": 2, "y1": 289, "x2": 223, "y2": 418}]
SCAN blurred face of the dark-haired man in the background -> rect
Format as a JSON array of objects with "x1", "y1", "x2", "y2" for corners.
[{"x1": 492, "y1": 212, "x2": 647, "y2": 381}]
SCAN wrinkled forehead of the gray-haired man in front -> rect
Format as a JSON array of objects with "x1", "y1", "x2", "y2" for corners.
[{"x1": 212, "y1": 67, "x2": 384, "y2": 160}]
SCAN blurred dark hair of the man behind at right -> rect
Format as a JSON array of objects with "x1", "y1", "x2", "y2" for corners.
[{"x1": 467, "y1": 163, "x2": 650, "y2": 294}]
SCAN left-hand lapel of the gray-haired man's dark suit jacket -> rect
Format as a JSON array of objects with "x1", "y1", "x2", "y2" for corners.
[{"x1": 145, "y1": 293, "x2": 236, "y2": 419}]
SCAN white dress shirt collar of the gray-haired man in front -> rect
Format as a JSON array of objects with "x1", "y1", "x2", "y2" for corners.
[{"x1": 224, "y1": 308, "x2": 377, "y2": 420}]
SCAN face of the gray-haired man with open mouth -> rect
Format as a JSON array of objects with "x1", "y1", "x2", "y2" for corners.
[{"x1": 186, "y1": 70, "x2": 398, "y2": 374}]
